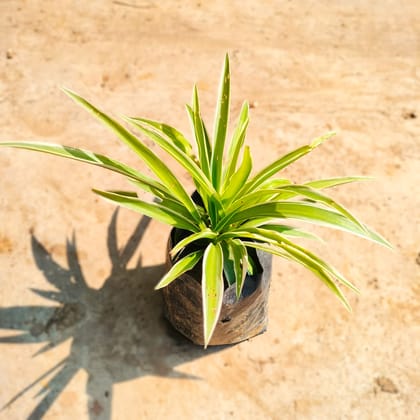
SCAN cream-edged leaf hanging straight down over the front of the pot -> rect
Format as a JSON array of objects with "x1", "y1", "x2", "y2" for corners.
[{"x1": 202, "y1": 243, "x2": 224, "y2": 348}]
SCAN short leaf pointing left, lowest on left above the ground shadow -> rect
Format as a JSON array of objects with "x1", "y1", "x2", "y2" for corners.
[{"x1": 92, "y1": 189, "x2": 199, "y2": 232}]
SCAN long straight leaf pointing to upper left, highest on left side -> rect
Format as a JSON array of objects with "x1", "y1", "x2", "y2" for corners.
[{"x1": 63, "y1": 89, "x2": 200, "y2": 222}]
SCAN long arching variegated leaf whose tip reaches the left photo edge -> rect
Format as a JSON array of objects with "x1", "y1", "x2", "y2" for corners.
[{"x1": 0, "y1": 141, "x2": 170, "y2": 195}]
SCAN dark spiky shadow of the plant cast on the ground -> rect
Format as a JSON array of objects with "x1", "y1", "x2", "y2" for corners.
[{"x1": 0, "y1": 209, "x2": 223, "y2": 419}]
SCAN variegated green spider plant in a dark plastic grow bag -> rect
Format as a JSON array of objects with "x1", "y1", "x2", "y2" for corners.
[{"x1": 2, "y1": 55, "x2": 389, "y2": 347}]
